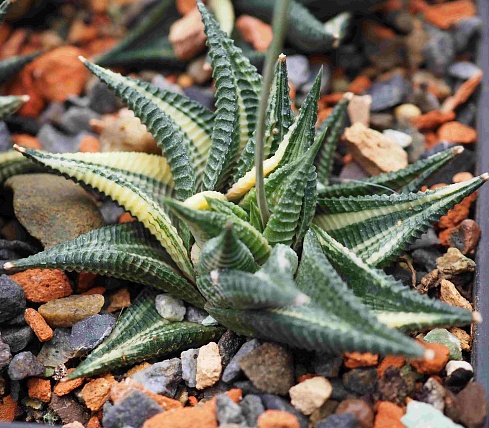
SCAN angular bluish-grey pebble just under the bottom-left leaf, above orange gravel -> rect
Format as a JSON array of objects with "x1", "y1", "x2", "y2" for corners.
[{"x1": 132, "y1": 358, "x2": 182, "y2": 398}]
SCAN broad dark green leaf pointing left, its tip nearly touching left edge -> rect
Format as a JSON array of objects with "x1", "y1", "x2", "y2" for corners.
[{"x1": 5, "y1": 222, "x2": 204, "y2": 307}]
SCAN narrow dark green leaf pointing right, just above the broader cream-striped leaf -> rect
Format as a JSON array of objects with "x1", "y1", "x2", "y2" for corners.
[{"x1": 318, "y1": 146, "x2": 463, "y2": 199}]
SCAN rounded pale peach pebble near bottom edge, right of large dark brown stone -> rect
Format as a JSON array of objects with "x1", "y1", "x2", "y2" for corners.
[{"x1": 289, "y1": 376, "x2": 333, "y2": 415}]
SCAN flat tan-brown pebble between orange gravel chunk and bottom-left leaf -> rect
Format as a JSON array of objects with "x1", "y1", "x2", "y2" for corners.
[{"x1": 38, "y1": 294, "x2": 104, "y2": 327}]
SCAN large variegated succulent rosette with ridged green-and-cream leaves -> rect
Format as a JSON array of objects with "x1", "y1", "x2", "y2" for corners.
[{"x1": 0, "y1": 3, "x2": 488, "y2": 378}]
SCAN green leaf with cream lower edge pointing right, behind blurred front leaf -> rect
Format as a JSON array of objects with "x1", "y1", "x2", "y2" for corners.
[{"x1": 313, "y1": 226, "x2": 472, "y2": 330}]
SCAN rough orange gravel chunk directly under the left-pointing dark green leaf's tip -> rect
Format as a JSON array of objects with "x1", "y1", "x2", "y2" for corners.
[{"x1": 10, "y1": 269, "x2": 72, "y2": 303}]
